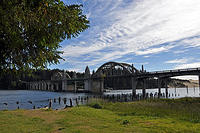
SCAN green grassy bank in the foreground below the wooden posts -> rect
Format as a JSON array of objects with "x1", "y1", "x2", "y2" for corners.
[{"x1": 0, "y1": 98, "x2": 200, "y2": 133}]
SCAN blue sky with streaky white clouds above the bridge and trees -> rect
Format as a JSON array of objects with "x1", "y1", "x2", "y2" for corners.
[{"x1": 50, "y1": 0, "x2": 200, "y2": 79}]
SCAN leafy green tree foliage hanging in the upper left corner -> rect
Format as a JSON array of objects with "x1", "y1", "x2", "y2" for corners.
[{"x1": 0, "y1": 0, "x2": 89, "y2": 71}]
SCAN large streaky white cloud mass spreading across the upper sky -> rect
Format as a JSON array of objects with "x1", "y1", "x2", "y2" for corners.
[{"x1": 60, "y1": 0, "x2": 200, "y2": 70}]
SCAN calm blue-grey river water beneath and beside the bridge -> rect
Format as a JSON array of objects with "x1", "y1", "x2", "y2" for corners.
[{"x1": 0, "y1": 88, "x2": 200, "y2": 110}]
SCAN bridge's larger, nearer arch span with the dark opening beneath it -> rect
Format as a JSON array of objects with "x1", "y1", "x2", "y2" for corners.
[{"x1": 91, "y1": 62, "x2": 141, "y2": 89}]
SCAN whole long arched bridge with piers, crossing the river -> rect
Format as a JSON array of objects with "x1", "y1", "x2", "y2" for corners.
[{"x1": 27, "y1": 62, "x2": 200, "y2": 96}]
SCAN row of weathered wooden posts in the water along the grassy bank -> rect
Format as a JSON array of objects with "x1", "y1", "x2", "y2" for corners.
[{"x1": 3, "y1": 92, "x2": 200, "y2": 109}]
